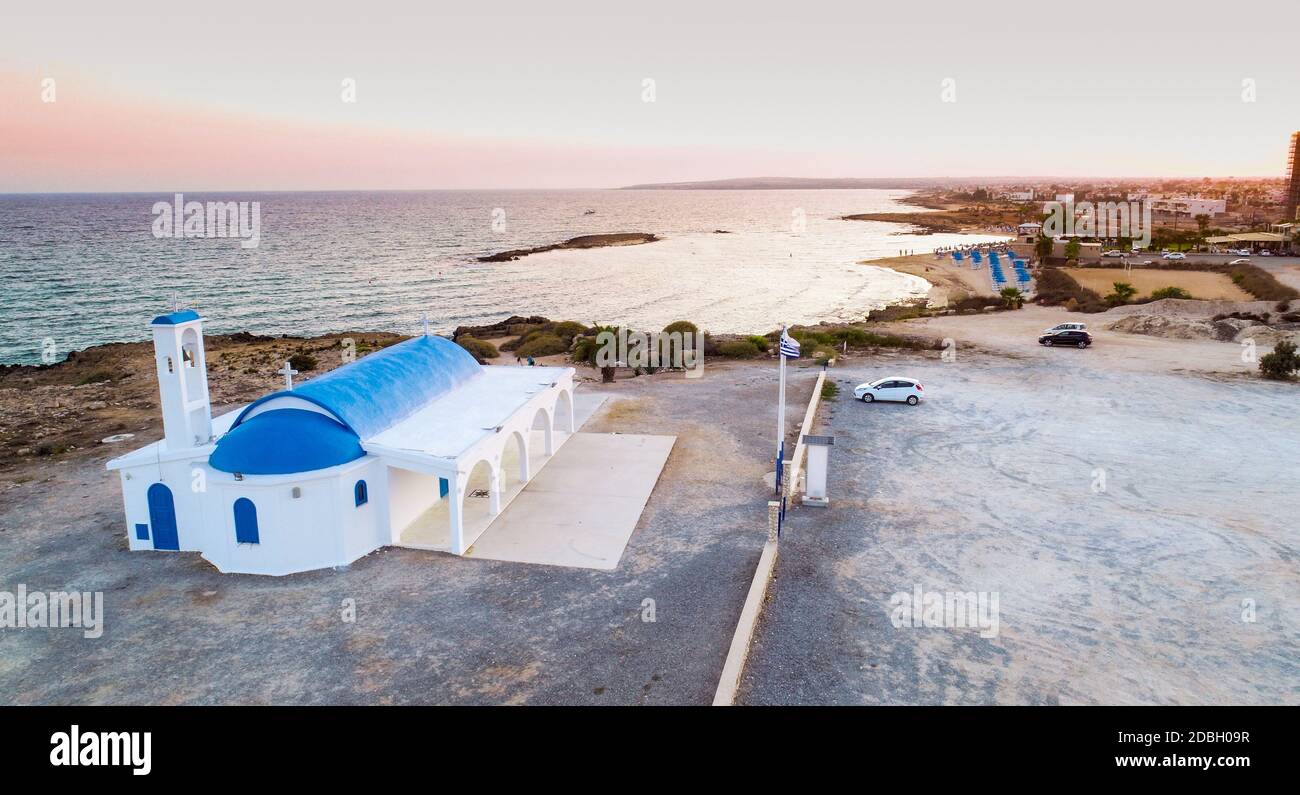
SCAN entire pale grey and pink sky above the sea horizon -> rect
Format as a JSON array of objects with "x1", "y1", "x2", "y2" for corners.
[{"x1": 0, "y1": 0, "x2": 1300, "y2": 192}]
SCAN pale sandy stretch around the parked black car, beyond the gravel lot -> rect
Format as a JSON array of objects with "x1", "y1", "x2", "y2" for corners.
[{"x1": 884, "y1": 304, "x2": 1258, "y2": 378}]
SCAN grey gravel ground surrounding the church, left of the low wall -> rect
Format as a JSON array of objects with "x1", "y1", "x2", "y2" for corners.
[{"x1": 0, "y1": 362, "x2": 815, "y2": 704}]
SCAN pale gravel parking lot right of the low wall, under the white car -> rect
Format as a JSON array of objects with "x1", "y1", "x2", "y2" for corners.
[{"x1": 741, "y1": 355, "x2": 1300, "y2": 704}]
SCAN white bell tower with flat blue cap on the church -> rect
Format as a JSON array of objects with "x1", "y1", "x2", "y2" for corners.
[{"x1": 150, "y1": 309, "x2": 212, "y2": 449}]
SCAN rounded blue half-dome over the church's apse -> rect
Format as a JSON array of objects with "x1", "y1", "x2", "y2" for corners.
[{"x1": 208, "y1": 409, "x2": 365, "y2": 474}]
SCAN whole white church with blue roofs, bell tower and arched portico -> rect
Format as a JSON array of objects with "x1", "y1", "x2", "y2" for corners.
[{"x1": 108, "y1": 310, "x2": 575, "y2": 574}]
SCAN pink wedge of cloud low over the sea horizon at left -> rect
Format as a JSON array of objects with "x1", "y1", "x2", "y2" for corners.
[{"x1": 0, "y1": 73, "x2": 790, "y2": 191}]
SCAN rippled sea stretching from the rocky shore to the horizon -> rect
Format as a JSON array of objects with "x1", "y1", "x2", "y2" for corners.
[{"x1": 0, "y1": 190, "x2": 991, "y2": 362}]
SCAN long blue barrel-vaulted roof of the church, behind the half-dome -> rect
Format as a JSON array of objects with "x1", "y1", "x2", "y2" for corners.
[{"x1": 231, "y1": 335, "x2": 481, "y2": 439}]
